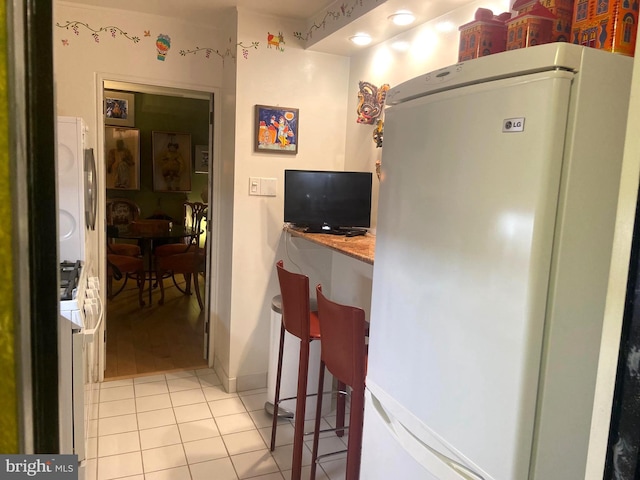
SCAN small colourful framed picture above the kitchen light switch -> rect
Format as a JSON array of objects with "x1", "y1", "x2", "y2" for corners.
[{"x1": 254, "y1": 105, "x2": 300, "y2": 155}]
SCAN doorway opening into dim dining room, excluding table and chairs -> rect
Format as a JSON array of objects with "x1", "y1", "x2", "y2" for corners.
[{"x1": 100, "y1": 80, "x2": 214, "y2": 380}]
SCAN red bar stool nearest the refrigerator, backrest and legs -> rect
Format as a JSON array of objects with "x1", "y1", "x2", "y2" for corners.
[{"x1": 310, "y1": 285, "x2": 368, "y2": 480}]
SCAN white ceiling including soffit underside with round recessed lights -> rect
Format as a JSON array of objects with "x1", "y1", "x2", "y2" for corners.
[{"x1": 64, "y1": 0, "x2": 490, "y2": 56}]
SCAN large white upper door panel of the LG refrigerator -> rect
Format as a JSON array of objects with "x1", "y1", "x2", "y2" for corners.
[{"x1": 363, "y1": 71, "x2": 573, "y2": 479}]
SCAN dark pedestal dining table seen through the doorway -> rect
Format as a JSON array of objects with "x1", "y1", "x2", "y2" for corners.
[{"x1": 107, "y1": 225, "x2": 198, "y2": 306}]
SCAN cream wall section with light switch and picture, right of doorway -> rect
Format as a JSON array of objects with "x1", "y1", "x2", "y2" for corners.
[{"x1": 228, "y1": 11, "x2": 349, "y2": 390}]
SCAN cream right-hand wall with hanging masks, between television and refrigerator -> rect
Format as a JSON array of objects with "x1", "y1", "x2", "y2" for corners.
[{"x1": 318, "y1": 0, "x2": 509, "y2": 334}]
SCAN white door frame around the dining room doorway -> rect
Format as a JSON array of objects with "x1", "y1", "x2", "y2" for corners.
[{"x1": 95, "y1": 73, "x2": 221, "y2": 382}]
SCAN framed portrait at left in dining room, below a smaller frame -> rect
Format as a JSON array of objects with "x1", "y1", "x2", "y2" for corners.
[{"x1": 104, "y1": 127, "x2": 140, "y2": 190}]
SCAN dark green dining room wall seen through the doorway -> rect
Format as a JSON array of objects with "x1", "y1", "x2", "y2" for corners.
[{"x1": 107, "y1": 93, "x2": 209, "y2": 221}]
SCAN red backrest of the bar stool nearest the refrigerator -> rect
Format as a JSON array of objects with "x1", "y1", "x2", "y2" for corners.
[{"x1": 316, "y1": 285, "x2": 367, "y2": 386}]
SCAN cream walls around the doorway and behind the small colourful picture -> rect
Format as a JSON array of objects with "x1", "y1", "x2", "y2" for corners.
[{"x1": 54, "y1": 1, "x2": 349, "y2": 390}]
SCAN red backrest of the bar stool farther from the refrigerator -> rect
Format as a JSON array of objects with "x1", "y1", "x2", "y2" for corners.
[{"x1": 276, "y1": 260, "x2": 311, "y2": 341}]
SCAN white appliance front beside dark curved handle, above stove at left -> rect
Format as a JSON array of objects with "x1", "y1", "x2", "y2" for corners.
[{"x1": 56, "y1": 117, "x2": 86, "y2": 261}]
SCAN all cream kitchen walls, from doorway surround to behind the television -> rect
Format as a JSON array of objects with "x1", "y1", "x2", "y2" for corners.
[{"x1": 54, "y1": 1, "x2": 508, "y2": 390}]
